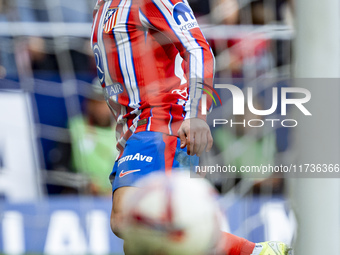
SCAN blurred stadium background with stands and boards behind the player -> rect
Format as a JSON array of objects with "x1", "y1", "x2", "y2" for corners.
[{"x1": 0, "y1": 0, "x2": 340, "y2": 254}]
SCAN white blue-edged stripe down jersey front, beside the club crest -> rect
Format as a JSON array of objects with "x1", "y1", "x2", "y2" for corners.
[{"x1": 113, "y1": 0, "x2": 141, "y2": 108}]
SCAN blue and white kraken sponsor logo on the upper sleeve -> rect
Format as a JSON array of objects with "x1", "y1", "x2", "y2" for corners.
[{"x1": 172, "y1": 3, "x2": 198, "y2": 32}]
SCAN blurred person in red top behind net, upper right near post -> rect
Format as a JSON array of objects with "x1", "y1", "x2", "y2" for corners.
[{"x1": 218, "y1": 1, "x2": 274, "y2": 78}]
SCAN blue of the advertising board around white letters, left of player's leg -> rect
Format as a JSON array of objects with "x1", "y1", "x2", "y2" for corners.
[{"x1": 0, "y1": 196, "x2": 123, "y2": 254}]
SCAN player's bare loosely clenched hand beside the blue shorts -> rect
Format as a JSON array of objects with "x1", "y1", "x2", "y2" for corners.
[{"x1": 177, "y1": 118, "x2": 213, "y2": 156}]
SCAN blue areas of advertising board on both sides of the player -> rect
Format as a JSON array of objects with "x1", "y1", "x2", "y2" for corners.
[{"x1": 0, "y1": 196, "x2": 286, "y2": 254}]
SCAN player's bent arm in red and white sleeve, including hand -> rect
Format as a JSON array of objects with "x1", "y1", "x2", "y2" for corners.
[{"x1": 140, "y1": 0, "x2": 215, "y2": 155}]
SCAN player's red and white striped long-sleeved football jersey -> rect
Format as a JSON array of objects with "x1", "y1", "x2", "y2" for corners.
[{"x1": 91, "y1": 0, "x2": 214, "y2": 151}]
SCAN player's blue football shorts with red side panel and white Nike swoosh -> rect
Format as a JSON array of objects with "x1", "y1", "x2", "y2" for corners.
[{"x1": 110, "y1": 131, "x2": 199, "y2": 192}]
